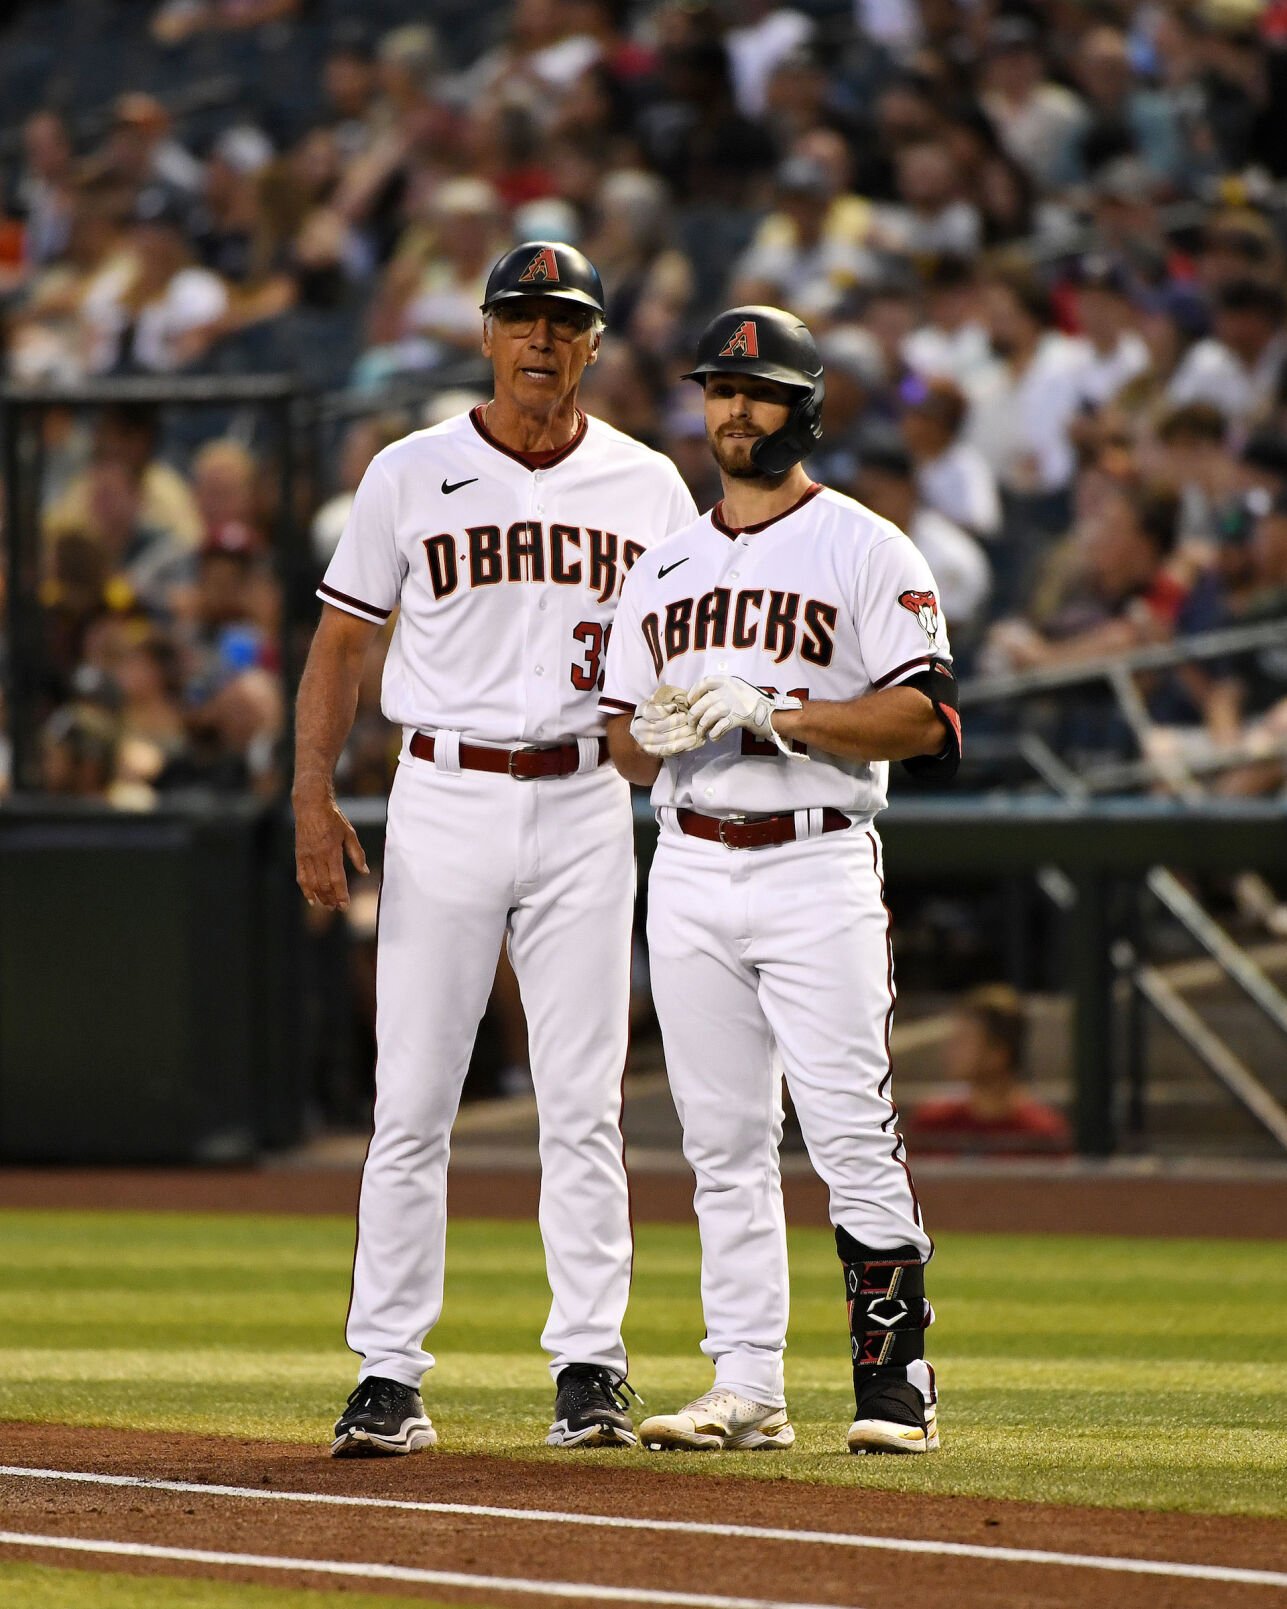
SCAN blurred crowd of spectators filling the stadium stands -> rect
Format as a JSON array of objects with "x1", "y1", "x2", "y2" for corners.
[{"x1": 0, "y1": 0, "x2": 1287, "y2": 808}]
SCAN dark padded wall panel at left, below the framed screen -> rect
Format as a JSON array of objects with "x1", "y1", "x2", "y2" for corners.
[{"x1": 0, "y1": 806, "x2": 302, "y2": 1162}]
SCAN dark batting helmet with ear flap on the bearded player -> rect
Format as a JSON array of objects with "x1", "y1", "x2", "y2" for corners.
[{"x1": 684, "y1": 307, "x2": 827, "y2": 475}]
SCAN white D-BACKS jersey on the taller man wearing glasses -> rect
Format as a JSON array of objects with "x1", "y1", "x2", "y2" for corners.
[{"x1": 317, "y1": 409, "x2": 697, "y2": 743}]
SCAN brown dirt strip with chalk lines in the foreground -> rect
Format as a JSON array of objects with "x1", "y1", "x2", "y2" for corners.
[{"x1": 0, "y1": 1424, "x2": 1287, "y2": 1609}]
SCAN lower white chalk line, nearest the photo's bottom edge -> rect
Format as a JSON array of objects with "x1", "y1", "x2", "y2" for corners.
[{"x1": 0, "y1": 1530, "x2": 837, "y2": 1609}]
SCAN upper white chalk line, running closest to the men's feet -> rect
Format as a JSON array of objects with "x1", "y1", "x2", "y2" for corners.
[{"x1": 0, "y1": 1464, "x2": 1287, "y2": 1586}]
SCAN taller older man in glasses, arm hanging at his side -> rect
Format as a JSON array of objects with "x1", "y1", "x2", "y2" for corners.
[{"x1": 293, "y1": 241, "x2": 695, "y2": 1458}]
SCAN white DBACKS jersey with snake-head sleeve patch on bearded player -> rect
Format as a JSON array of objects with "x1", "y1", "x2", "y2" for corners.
[{"x1": 602, "y1": 484, "x2": 951, "y2": 821}]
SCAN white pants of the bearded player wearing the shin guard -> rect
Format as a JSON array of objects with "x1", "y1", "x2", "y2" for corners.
[{"x1": 648, "y1": 825, "x2": 931, "y2": 1406}]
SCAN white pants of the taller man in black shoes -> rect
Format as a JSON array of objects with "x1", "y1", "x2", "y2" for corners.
[{"x1": 346, "y1": 742, "x2": 634, "y2": 1387}]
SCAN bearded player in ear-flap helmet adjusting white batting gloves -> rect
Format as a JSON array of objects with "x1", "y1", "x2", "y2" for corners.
[{"x1": 602, "y1": 307, "x2": 960, "y2": 1453}]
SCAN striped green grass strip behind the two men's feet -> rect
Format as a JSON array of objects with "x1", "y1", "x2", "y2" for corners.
[{"x1": 0, "y1": 1212, "x2": 1287, "y2": 1525}]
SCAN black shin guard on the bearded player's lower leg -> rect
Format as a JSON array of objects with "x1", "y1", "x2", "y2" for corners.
[{"x1": 835, "y1": 1229, "x2": 931, "y2": 1416}]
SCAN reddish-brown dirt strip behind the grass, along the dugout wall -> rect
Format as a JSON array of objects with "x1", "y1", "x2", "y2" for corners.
[{"x1": 0, "y1": 1167, "x2": 1287, "y2": 1239}]
